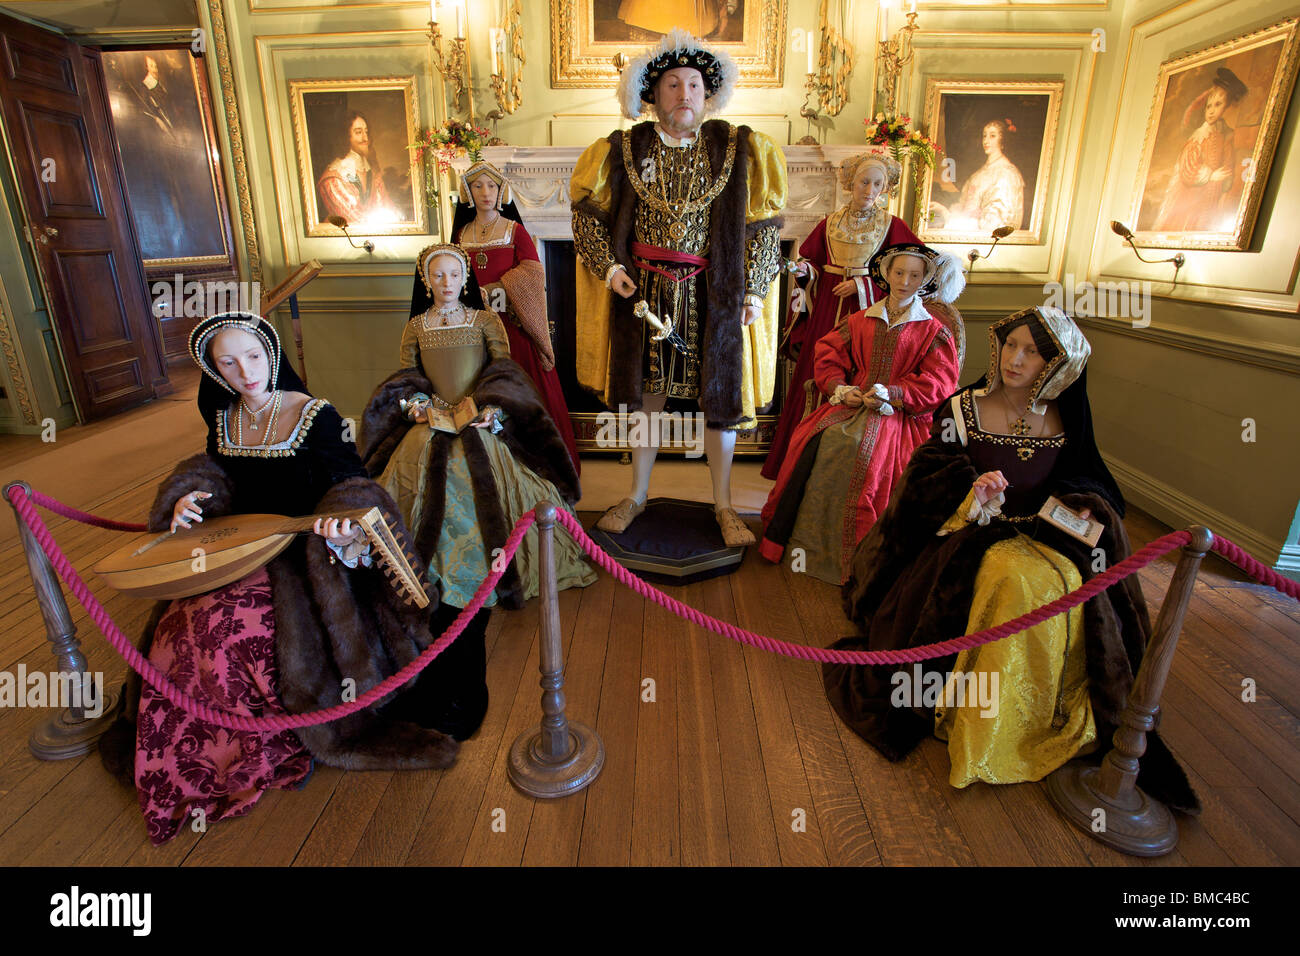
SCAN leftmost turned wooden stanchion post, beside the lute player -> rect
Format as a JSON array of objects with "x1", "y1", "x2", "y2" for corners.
[{"x1": 4, "y1": 481, "x2": 122, "y2": 760}]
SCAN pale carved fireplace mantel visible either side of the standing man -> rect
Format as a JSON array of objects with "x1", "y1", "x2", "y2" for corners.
[{"x1": 484, "y1": 144, "x2": 863, "y2": 243}]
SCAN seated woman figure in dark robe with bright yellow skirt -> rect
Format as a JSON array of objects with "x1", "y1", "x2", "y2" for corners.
[{"x1": 823, "y1": 307, "x2": 1199, "y2": 812}]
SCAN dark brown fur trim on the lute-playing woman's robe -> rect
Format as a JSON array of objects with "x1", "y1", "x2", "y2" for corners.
[{"x1": 100, "y1": 454, "x2": 459, "y2": 784}]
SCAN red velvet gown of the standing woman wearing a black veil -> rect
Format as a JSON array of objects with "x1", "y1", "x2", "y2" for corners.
[{"x1": 456, "y1": 220, "x2": 582, "y2": 471}]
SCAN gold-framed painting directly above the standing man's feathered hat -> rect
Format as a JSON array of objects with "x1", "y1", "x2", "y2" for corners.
[{"x1": 551, "y1": 0, "x2": 788, "y2": 90}]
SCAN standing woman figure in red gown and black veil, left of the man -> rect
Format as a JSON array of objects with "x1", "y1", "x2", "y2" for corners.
[{"x1": 411, "y1": 161, "x2": 582, "y2": 473}]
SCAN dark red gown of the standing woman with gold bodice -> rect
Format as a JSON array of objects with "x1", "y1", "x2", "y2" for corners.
[{"x1": 762, "y1": 211, "x2": 919, "y2": 479}]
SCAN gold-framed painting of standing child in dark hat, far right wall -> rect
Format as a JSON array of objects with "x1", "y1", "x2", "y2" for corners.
[{"x1": 1128, "y1": 17, "x2": 1300, "y2": 251}]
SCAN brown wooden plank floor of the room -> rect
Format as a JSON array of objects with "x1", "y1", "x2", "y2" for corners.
[{"x1": 0, "y1": 403, "x2": 1300, "y2": 866}]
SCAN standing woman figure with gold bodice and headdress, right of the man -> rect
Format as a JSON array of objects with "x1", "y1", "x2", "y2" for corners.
[{"x1": 763, "y1": 147, "x2": 918, "y2": 479}]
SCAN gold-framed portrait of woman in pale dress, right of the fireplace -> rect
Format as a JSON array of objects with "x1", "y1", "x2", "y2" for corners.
[{"x1": 917, "y1": 78, "x2": 1065, "y2": 246}]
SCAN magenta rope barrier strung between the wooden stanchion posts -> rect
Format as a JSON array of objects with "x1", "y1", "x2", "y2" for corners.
[{"x1": 9, "y1": 488, "x2": 1300, "y2": 731}]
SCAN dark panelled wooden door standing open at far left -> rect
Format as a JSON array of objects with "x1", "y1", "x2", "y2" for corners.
[{"x1": 0, "y1": 16, "x2": 169, "y2": 421}]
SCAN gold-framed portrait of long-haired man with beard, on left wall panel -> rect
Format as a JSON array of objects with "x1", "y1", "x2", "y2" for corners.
[{"x1": 289, "y1": 77, "x2": 428, "y2": 237}]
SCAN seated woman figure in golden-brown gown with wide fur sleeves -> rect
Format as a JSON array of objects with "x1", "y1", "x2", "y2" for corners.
[{"x1": 361, "y1": 245, "x2": 595, "y2": 624}]
